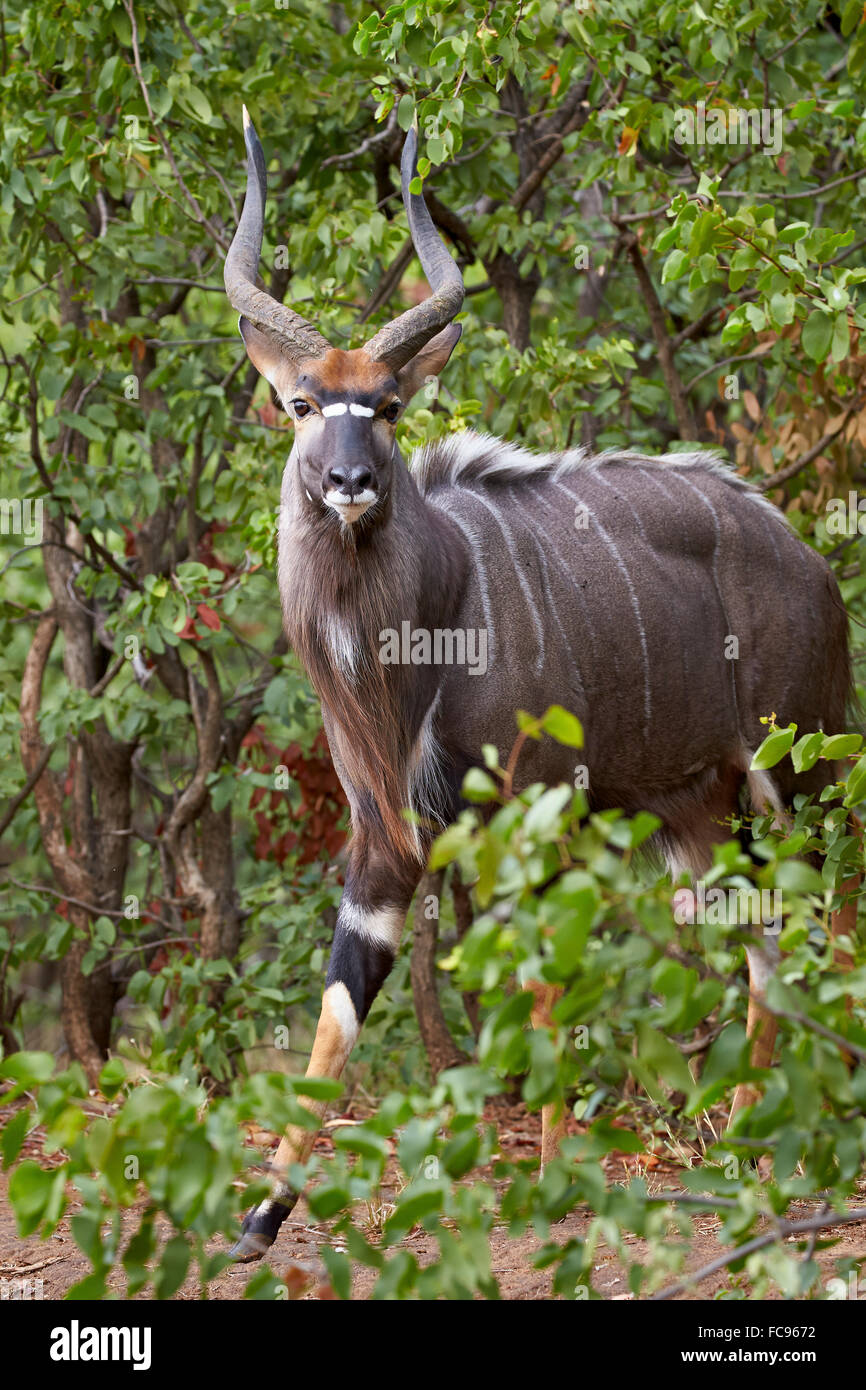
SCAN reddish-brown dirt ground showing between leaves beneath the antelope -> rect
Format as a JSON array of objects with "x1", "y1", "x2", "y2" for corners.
[{"x1": 0, "y1": 1104, "x2": 866, "y2": 1300}]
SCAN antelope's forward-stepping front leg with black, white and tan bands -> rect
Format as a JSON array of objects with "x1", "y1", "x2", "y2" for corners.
[{"x1": 231, "y1": 837, "x2": 421, "y2": 1262}]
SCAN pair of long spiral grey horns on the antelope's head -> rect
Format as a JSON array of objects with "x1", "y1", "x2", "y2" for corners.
[{"x1": 224, "y1": 107, "x2": 463, "y2": 371}]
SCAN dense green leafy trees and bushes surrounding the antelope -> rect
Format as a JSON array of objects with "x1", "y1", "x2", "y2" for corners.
[{"x1": 0, "y1": 0, "x2": 866, "y2": 1297}]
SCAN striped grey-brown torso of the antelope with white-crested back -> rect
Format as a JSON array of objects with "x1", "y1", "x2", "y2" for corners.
[{"x1": 410, "y1": 432, "x2": 849, "y2": 809}]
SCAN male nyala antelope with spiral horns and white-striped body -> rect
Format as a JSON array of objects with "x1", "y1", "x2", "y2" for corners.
[{"x1": 225, "y1": 110, "x2": 851, "y2": 1259}]
